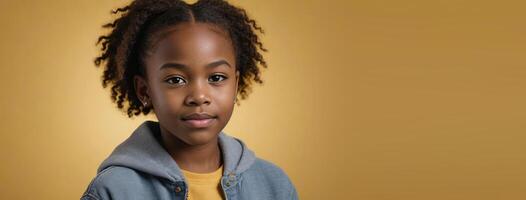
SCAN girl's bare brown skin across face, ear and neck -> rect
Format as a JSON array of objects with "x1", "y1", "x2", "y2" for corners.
[{"x1": 134, "y1": 22, "x2": 239, "y2": 173}]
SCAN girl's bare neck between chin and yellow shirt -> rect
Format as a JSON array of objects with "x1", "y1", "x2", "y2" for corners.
[{"x1": 161, "y1": 128, "x2": 222, "y2": 173}]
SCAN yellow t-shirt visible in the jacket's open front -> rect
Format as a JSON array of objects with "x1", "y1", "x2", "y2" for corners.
[{"x1": 181, "y1": 165, "x2": 224, "y2": 200}]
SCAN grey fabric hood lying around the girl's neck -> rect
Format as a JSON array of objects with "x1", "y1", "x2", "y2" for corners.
[{"x1": 97, "y1": 120, "x2": 256, "y2": 182}]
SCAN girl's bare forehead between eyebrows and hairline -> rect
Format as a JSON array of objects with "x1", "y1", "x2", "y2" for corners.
[{"x1": 153, "y1": 22, "x2": 234, "y2": 60}]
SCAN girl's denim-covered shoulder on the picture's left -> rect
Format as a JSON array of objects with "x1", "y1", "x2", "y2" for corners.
[{"x1": 81, "y1": 166, "x2": 161, "y2": 200}]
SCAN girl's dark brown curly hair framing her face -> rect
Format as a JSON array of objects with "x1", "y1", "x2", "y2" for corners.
[{"x1": 94, "y1": 0, "x2": 267, "y2": 118}]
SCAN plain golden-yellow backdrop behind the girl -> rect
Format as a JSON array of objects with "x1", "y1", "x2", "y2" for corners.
[{"x1": 0, "y1": 0, "x2": 526, "y2": 200}]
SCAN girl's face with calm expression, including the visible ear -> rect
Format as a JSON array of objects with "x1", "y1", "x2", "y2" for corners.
[{"x1": 135, "y1": 22, "x2": 239, "y2": 145}]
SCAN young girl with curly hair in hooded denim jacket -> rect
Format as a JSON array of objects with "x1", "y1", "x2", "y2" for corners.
[{"x1": 82, "y1": 0, "x2": 298, "y2": 200}]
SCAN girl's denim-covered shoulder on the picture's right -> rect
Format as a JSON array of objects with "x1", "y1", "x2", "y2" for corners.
[{"x1": 243, "y1": 158, "x2": 297, "y2": 199}]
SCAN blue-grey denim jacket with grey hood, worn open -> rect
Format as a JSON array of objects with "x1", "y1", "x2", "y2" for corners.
[{"x1": 81, "y1": 121, "x2": 298, "y2": 200}]
